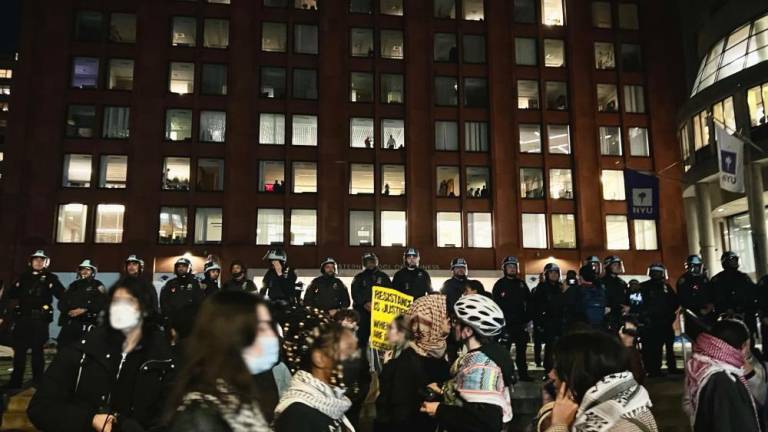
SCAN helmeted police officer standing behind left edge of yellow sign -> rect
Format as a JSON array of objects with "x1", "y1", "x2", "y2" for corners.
[{"x1": 352, "y1": 252, "x2": 392, "y2": 348}]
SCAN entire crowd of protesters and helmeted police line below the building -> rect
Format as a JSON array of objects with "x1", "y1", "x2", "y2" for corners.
[{"x1": 2, "y1": 248, "x2": 768, "y2": 432}]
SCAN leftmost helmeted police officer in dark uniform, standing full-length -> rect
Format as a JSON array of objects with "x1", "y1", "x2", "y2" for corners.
[{"x1": 6, "y1": 250, "x2": 64, "y2": 388}]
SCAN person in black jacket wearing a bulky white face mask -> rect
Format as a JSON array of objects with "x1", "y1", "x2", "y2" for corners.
[{"x1": 27, "y1": 278, "x2": 174, "y2": 432}]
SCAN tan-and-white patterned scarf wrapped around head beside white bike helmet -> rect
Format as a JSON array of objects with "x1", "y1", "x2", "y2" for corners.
[{"x1": 408, "y1": 294, "x2": 450, "y2": 358}]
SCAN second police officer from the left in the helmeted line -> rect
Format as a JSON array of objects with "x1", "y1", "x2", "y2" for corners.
[{"x1": 56, "y1": 259, "x2": 108, "y2": 349}]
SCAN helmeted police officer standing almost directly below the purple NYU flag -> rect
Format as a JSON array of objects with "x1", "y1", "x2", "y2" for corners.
[{"x1": 639, "y1": 263, "x2": 680, "y2": 376}]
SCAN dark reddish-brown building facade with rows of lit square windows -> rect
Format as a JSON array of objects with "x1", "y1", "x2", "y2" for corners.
[{"x1": 0, "y1": 0, "x2": 688, "y2": 284}]
